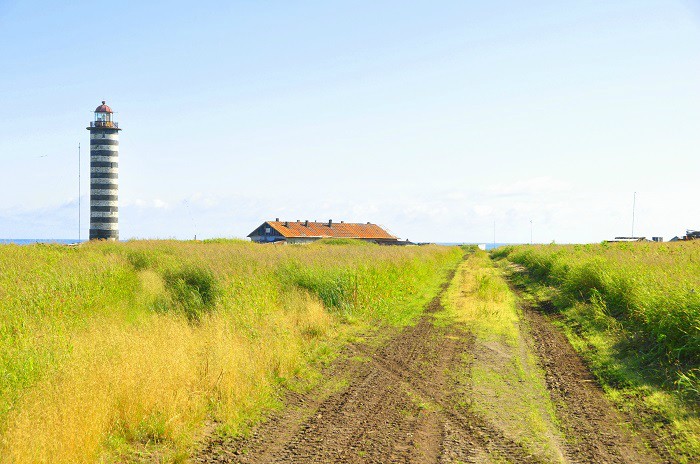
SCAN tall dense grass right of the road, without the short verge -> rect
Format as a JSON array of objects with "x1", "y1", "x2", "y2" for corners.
[{"x1": 495, "y1": 242, "x2": 700, "y2": 380}]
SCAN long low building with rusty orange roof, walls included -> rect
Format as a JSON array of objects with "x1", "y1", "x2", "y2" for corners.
[{"x1": 248, "y1": 218, "x2": 402, "y2": 245}]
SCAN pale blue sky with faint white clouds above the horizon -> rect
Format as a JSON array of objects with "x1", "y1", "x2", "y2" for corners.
[{"x1": 0, "y1": 0, "x2": 700, "y2": 243}]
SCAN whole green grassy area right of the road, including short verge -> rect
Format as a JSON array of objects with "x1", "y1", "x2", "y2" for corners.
[{"x1": 492, "y1": 242, "x2": 700, "y2": 462}]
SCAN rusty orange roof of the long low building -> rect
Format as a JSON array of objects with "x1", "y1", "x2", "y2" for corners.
[{"x1": 267, "y1": 221, "x2": 398, "y2": 240}]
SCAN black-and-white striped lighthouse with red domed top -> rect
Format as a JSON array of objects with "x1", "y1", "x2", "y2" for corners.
[{"x1": 87, "y1": 101, "x2": 121, "y2": 240}]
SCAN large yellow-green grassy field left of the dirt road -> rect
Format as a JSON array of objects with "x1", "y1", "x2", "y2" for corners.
[{"x1": 0, "y1": 240, "x2": 462, "y2": 463}]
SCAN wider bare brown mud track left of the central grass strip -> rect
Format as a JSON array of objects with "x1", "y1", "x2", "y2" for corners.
[{"x1": 200, "y1": 268, "x2": 538, "y2": 464}]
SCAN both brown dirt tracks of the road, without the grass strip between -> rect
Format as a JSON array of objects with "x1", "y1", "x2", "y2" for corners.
[{"x1": 195, "y1": 264, "x2": 663, "y2": 463}]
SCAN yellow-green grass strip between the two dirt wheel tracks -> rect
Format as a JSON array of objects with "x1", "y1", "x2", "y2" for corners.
[{"x1": 438, "y1": 251, "x2": 564, "y2": 462}]
